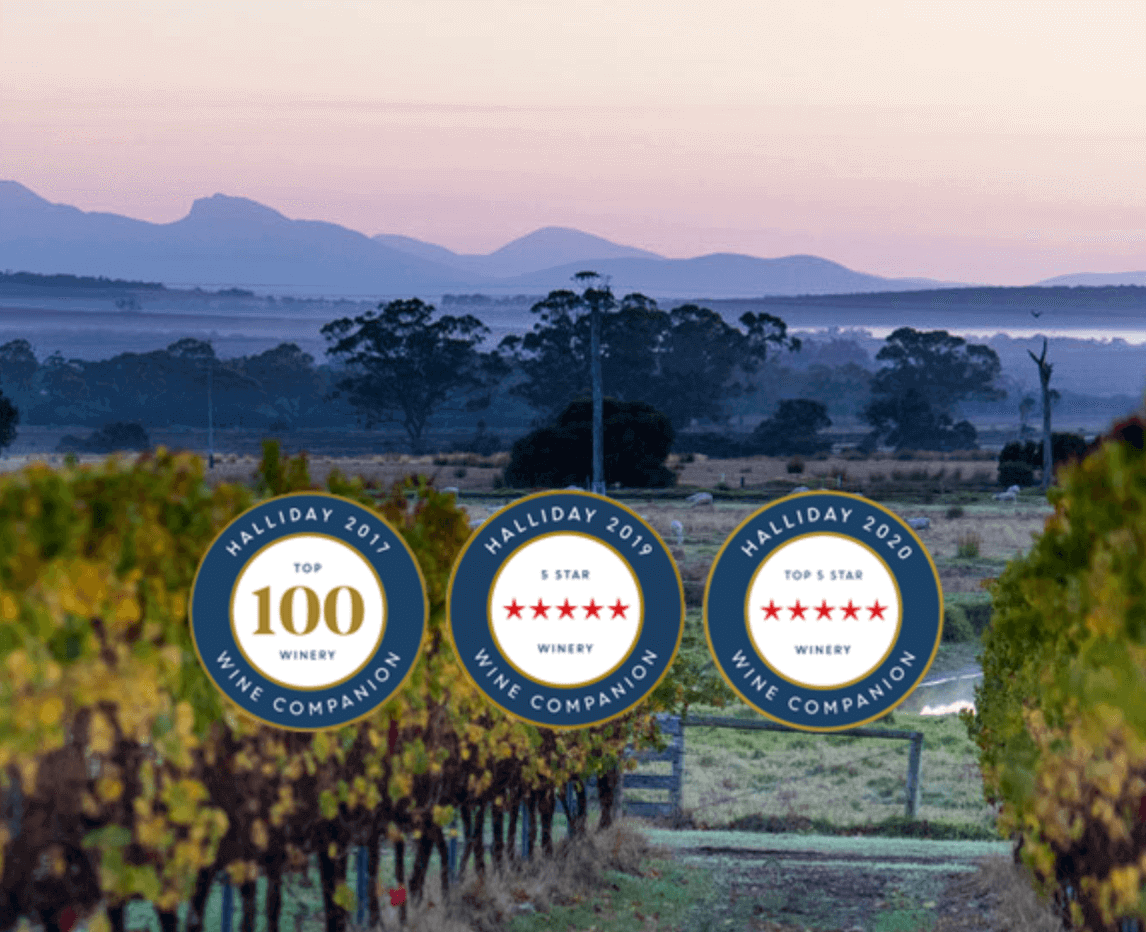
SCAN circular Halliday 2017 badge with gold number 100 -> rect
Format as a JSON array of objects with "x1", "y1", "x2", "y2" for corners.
[{"x1": 190, "y1": 492, "x2": 429, "y2": 731}]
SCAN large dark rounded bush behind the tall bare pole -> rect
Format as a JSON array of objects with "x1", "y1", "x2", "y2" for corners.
[{"x1": 504, "y1": 398, "x2": 676, "y2": 488}]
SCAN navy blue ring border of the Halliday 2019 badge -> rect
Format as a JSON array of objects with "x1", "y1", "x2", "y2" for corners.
[{"x1": 446, "y1": 491, "x2": 684, "y2": 731}]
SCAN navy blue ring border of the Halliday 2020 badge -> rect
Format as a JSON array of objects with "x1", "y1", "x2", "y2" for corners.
[{"x1": 704, "y1": 491, "x2": 943, "y2": 731}]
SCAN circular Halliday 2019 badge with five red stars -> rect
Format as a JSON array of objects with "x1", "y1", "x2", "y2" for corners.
[{"x1": 446, "y1": 491, "x2": 684, "y2": 729}]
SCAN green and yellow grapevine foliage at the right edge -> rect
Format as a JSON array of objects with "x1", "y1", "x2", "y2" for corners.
[{"x1": 963, "y1": 424, "x2": 1146, "y2": 930}]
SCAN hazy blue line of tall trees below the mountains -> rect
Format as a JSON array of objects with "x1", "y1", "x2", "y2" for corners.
[{"x1": 0, "y1": 272, "x2": 1005, "y2": 453}]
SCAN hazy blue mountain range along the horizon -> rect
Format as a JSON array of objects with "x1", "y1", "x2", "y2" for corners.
[{"x1": 0, "y1": 180, "x2": 1146, "y2": 299}]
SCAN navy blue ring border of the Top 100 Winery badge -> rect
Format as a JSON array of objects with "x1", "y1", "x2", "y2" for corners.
[{"x1": 189, "y1": 492, "x2": 430, "y2": 731}]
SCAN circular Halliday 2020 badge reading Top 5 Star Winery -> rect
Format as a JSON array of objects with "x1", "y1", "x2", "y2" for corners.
[{"x1": 704, "y1": 492, "x2": 943, "y2": 731}]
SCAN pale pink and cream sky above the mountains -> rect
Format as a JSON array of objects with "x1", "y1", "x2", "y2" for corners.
[{"x1": 0, "y1": 0, "x2": 1146, "y2": 284}]
